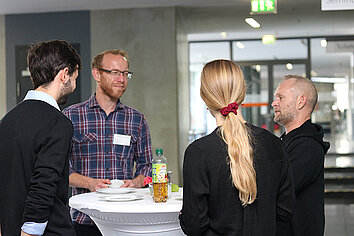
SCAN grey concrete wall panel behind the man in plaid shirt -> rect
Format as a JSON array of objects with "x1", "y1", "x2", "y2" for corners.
[{"x1": 91, "y1": 7, "x2": 188, "y2": 184}]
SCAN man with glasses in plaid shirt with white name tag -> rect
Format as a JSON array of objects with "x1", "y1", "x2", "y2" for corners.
[{"x1": 63, "y1": 50, "x2": 152, "y2": 236}]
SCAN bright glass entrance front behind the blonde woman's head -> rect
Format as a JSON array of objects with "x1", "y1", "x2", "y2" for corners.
[{"x1": 189, "y1": 39, "x2": 310, "y2": 142}]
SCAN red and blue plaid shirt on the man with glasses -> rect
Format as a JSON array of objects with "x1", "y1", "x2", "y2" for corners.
[{"x1": 63, "y1": 95, "x2": 152, "y2": 225}]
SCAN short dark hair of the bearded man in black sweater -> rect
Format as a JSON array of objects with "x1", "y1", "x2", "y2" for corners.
[{"x1": 27, "y1": 40, "x2": 81, "y2": 89}]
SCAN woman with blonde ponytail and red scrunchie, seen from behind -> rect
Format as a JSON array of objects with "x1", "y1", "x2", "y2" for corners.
[{"x1": 179, "y1": 60, "x2": 294, "y2": 236}]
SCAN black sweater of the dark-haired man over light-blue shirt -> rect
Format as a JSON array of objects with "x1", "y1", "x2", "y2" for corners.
[{"x1": 0, "y1": 100, "x2": 75, "y2": 236}]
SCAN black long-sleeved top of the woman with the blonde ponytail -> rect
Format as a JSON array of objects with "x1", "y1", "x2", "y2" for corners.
[{"x1": 179, "y1": 124, "x2": 295, "y2": 236}]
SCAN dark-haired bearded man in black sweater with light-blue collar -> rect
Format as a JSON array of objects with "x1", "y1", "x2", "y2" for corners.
[{"x1": 0, "y1": 40, "x2": 81, "y2": 236}]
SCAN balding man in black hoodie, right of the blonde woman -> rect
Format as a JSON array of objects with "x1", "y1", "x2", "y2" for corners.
[{"x1": 272, "y1": 75, "x2": 329, "y2": 236}]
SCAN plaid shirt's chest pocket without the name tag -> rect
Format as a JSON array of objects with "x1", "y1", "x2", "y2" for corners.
[{"x1": 72, "y1": 133, "x2": 98, "y2": 158}]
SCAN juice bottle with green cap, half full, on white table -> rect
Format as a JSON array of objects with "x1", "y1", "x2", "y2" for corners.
[{"x1": 152, "y1": 149, "x2": 168, "y2": 202}]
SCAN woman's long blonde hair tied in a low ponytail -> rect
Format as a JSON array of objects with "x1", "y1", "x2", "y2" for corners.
[{"x1": 200, "y1": 60, "x2": 257, "y2": 206}]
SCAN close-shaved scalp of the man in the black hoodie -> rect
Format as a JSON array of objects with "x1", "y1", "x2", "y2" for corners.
[{"x1": 284, "y1": 75, "x2": 318, "y2": 113}]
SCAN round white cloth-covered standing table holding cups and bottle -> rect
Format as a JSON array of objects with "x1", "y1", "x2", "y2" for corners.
[{"x1": 69, "y1": 188, "x2": 184, "y2": 236}]
